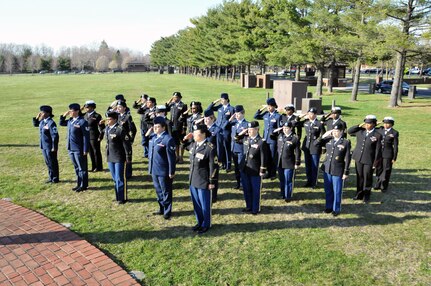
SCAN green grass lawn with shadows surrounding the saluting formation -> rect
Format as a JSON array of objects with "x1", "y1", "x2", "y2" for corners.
[{"x1": 0, "y1": 74, "x2": 431, "y2": 285}]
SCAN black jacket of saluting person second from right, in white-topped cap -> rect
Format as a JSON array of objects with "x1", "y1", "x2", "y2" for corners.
[{"x1": 348, "y1": 125, "x2": 382, "y2": 167}]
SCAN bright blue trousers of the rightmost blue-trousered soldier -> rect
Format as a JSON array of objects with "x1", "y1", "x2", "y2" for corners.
[{"x1": 323, "y1": 172, "x2": 343, "y2": 213}]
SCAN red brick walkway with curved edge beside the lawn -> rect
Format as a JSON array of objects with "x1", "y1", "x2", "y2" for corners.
[{"x1": 0, "y1": 200, "x2": 139, "y2": 286}]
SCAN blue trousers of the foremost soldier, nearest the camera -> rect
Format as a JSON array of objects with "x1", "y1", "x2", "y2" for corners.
[{"x1": 190, "y1": 186, "x2": 211, "y2": 228}]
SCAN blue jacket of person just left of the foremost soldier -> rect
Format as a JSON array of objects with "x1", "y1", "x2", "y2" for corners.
[{"x1": 148, "y1": 131, "x2": 176, "y2": 176}]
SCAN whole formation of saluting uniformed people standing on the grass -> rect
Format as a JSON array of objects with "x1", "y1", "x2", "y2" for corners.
[{"x1": 33, "y1": 92, "x2": 399, "y2": 234}]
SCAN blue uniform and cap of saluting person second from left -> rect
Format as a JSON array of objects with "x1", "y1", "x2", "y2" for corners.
[{"x1": 60, "y1": 103, "x2": 90, "y2": 192}]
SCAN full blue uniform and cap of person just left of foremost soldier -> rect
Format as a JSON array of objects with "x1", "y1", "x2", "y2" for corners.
[{"x1": 148, "y1": 117, "x2": 176, "y2": 219}]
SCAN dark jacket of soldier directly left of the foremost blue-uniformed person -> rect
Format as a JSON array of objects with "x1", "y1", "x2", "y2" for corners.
[{"x1": 105, "y1": 123, "x2": 132, "y2": 163}]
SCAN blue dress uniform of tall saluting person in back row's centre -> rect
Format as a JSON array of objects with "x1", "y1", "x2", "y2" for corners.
[{"x1": 207, "y1": 93, "x2": 235, "y2": 170}]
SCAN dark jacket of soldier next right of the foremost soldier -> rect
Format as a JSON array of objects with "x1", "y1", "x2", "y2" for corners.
[{"x1": 239, "y1": 135, "x2": 270, "y2": 176}]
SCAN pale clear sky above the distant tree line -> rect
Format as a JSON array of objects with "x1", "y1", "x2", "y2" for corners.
[{"x1": 0, "y1": 0, "x2": 223, "y2": 54}]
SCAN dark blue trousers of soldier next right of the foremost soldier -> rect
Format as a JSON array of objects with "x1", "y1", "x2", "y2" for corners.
[{"x1": 241, "y1": 172, "x2": 262, "y2": 213}]
